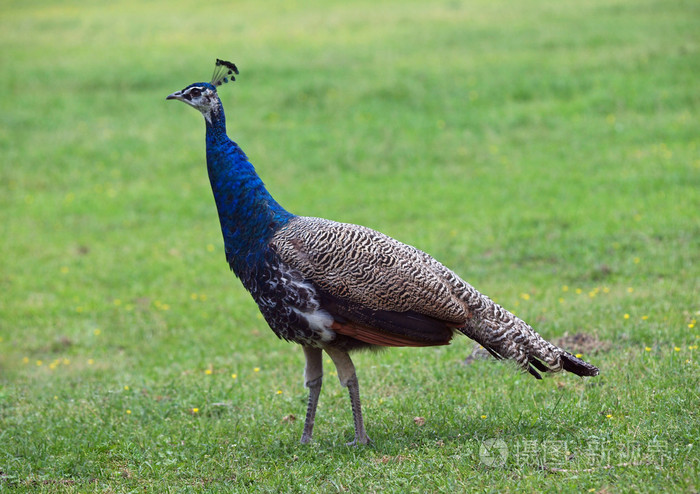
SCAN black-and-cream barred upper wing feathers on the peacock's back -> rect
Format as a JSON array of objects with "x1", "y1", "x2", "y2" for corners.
[{"x1": 272, "y1": 217, "x2": 469, "y2": 325}]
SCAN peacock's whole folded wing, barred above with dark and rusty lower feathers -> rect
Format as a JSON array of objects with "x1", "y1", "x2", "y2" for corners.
[{"x1": 271, "y1": 217, "x2": 469, "y2": 346}]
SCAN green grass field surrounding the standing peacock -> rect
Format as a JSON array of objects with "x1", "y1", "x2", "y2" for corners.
[{"x1": 0, "y1": 0, "x2": 700, "y2": 492}]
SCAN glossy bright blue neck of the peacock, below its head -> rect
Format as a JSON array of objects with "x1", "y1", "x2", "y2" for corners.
[{"x1": 205, "y1": 102, "x2": 294, "y2": 277}]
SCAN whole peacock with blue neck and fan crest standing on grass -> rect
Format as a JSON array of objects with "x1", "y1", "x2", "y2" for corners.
[{"x1": 166, "y1": 59, "x2": 598, "y2": 444}]
